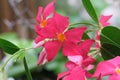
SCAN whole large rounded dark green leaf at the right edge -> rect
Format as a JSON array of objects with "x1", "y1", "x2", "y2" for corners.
[{"x1": 100, "y1": 26, "x2": 120, "y2": 60}]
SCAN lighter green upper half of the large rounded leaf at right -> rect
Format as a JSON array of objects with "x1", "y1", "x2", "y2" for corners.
[{"x1": 100, "y1": 26, "x2": 120, "y2": 48}]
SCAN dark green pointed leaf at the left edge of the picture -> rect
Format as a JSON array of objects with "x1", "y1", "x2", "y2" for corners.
[{"x1": 0, "y1": 38, "x2": 19, "y2": 55}]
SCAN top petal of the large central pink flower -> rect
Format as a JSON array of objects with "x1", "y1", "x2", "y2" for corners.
[{"x1": 54, "y1": 13, "x2": 69, "y2": 33}]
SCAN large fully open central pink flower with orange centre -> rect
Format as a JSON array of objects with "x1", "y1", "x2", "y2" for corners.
[{"x1": 36, "y1": 13, "x2": 86, "y2": 65}]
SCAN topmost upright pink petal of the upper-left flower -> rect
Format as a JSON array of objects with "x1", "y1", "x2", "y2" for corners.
[{"x1": 43, "y1": 1, "x2": 54, "y2": 19}]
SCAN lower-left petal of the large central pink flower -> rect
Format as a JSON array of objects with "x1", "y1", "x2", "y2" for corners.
[{"x1": 44, "y1": 41, "x2": 61, "y2": 61}]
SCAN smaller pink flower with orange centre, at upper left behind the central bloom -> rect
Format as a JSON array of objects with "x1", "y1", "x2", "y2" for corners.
[{"x1": 35, "y1": 0, "x2": 55, "y2": 39}]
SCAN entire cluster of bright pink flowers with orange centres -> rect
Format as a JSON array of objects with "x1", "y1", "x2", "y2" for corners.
[{"x1": 34, "y1": 1, "x2": 120, "y2": 80}]
